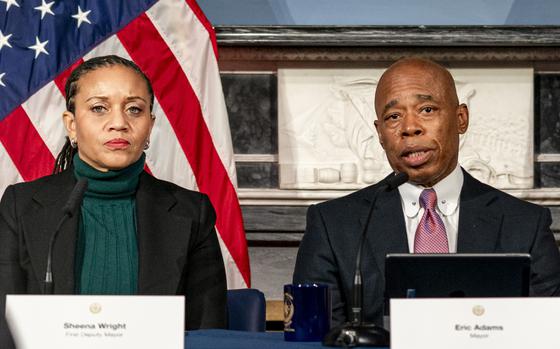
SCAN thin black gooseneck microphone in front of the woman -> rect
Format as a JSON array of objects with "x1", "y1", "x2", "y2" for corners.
[{"x1": 43, "y1": 178, "x2": 88, "y2": 294}]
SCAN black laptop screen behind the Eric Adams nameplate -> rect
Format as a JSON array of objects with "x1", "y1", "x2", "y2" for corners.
[{"x1": 385, "y1": 253, "x2": 531, "y2": 304}]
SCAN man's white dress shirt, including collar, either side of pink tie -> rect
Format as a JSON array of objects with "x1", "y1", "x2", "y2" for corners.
[{"x1": 399, "y1": 164, "x2": 463, "y2": 253}]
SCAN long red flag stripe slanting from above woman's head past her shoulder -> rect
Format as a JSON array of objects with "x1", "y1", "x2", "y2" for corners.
[{"x1": 117, "y1": 15, "x2": 250, "y2": 285}]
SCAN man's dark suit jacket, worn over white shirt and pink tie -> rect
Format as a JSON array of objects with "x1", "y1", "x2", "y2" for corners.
[{"x1": 294, "y1": 171, "x2": 560, "y2": 325}]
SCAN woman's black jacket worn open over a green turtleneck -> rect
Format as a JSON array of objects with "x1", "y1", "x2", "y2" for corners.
[{"x1": 0, "y1": 170, "x2": 227, "y2": 348}]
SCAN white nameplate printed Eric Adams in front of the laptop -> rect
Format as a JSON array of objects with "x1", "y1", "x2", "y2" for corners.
[{"x1": 391, "y1": 298, "x2": 560, "y2": 349}]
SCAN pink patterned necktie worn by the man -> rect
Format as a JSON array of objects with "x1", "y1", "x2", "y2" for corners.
[{"x1": 414, "y1": 189, "x2": 449, "y2": 253}]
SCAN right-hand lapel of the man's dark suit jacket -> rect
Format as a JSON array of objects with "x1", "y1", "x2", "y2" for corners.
[{"x1": 457, "y1": 170, "x2": 503, "y2": 253}]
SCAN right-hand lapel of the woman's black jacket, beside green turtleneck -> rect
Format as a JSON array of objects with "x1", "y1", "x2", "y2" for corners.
[{"x1": 136, "y1": 173, "x2": 192, "y2": 295}]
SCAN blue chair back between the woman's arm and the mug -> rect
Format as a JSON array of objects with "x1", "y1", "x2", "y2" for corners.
[{"x1": 227, "y1": 288, "x2": 266, "y2": 332}]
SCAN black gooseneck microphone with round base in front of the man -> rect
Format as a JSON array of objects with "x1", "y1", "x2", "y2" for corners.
[{"x1": 323, "y1": 172, "x2": 408, "y2": 347}]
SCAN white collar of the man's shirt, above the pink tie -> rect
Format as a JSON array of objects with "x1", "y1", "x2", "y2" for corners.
[{"x1": 399, "y1": 164, "x2": 463, "y2": 218}]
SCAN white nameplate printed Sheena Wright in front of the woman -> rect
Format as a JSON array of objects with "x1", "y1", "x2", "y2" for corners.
[{"x1": 6, "y1": 295, "x2": 185, "y2": 349}]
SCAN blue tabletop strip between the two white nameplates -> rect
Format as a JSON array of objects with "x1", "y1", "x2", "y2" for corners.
[{"x1": 185, "y1": 330, "x2": 388, "y2": 349}]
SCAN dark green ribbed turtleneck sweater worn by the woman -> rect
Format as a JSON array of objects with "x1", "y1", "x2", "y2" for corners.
[{"x1": 74, "y1": 154, "x2": 145, "y2": 295}]
